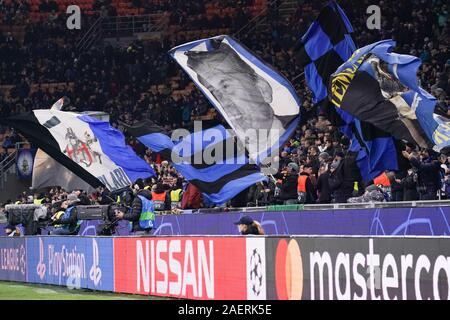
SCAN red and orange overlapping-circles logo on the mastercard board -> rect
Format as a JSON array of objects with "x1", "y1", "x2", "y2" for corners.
[{"x1": 275, "y1": 239, "x2": 303, "y2": 300}]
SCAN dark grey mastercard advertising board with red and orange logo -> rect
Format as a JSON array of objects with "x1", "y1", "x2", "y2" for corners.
[{"x1": 266, "y1": 237, "x2": 450, "y2": 300}]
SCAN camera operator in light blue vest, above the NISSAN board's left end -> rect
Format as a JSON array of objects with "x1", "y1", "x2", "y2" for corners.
[{"x1": 115, "y1": 189, "x2": 155, "y2": 235}]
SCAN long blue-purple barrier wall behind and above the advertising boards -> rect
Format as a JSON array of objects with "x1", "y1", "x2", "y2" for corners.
[{"x1": 0, "y1": 206, "x2": 450, "y2": 236}]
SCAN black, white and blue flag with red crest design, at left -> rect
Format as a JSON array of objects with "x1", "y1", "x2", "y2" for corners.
[{"x1": 1, "y1": 109, "x2": 155, "y2": 191}]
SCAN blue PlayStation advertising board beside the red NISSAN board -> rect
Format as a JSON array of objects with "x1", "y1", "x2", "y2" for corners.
[{"x1": 26, "y1": 236, "x2": 114, "y2": 291}]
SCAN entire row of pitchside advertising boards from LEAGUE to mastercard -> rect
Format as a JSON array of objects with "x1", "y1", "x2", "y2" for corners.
[{"x1": 0, "y1": 236, "x2": 450, "y2": 300}]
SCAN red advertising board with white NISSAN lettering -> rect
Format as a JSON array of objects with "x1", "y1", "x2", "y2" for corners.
[{"x1": 114, "y1": 237, "x2": 247, "y2": 299}]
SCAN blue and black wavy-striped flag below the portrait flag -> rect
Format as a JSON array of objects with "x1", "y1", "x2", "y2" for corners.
[{"x1": 127, "y1": 121, "x2": 267, "y2": 204}]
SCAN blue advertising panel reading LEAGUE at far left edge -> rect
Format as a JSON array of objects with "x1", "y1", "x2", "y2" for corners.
[{"x1": 0, "y1": 237, "x2": 27, "y2": 282}]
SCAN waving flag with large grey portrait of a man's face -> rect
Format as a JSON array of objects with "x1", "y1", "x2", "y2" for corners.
[{"x1": 169, "y1": 36, "x2": 300, "y2": 163}]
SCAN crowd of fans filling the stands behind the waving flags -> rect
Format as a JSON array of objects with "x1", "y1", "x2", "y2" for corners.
[{"x1": 0, "y1": 0, "x2": 450, "y2": 207}]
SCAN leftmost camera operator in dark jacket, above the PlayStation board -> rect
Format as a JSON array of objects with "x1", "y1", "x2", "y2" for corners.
[{"x1": 50, "y1": 193, "x2": 81, "y2": 235}]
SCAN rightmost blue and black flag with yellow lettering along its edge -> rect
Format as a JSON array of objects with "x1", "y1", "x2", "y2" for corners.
[{"x1": 329, "y1": 40, "x2": 438, "y2": 151}]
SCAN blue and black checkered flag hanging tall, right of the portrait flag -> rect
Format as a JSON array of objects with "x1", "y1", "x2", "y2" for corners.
[{"x1": 295, "y1": 1, "x2": 401, "y2": 181}]
